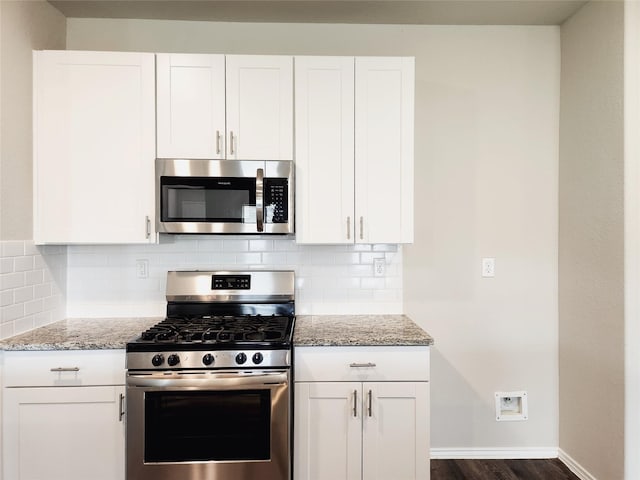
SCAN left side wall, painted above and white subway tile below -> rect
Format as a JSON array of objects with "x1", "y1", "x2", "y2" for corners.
[{"x1": 0, "y1": 0, "x2": 66, "y2": 338}]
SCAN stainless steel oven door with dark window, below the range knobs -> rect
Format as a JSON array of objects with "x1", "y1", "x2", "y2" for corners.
[{"x1": 127, "y1": 370, "x2": 291, "y2": 480}]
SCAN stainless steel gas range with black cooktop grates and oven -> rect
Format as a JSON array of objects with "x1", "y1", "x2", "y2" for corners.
[{"x1": 127, "y1": 271, "x2": 295, "y2": 480}]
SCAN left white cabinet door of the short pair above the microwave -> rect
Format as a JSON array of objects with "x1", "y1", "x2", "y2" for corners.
[{"x1": 156, "y1": 53, "x2": 225, "y2": 158}]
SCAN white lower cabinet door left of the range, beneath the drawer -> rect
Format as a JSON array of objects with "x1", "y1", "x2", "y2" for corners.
[{"x1": 2, "y1": 386, "x2": 125, "y2": 480}]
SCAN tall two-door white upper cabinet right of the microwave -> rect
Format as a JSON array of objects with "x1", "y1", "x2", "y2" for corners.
[{"x1": 295, "y1": 57, "x2": 414, "y2": 244}]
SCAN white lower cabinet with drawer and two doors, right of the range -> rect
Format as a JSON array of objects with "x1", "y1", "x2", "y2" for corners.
[{"x1": 294, "y1": 347, "x2": 430, "y2": 480}]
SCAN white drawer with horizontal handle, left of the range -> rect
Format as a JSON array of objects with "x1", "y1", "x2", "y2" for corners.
[{"x1": 3, "y1": 350, "x2": 125, "y2": 387}]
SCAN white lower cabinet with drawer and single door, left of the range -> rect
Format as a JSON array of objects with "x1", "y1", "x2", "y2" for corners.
[{"x1": 2, "y1": 351, "x2": 125, "y2": 480}]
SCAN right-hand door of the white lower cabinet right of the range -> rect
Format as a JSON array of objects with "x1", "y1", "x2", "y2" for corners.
[{"x1": 362, "y1": 382, "x2": 430, "y2": 480}]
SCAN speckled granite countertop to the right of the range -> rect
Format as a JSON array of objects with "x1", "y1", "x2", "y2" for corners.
[{"x1": 293, "y1": 315, "x2": 433, "y2": 347}]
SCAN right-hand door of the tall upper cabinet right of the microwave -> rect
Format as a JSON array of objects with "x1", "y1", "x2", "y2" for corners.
[{"x1": 355, "y1": 57, "x2": 414, "y2": 243}]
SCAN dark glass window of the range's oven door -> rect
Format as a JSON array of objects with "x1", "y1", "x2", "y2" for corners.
[{"x1": 144, "y1": 390, "x2": 271, "y2": 463}]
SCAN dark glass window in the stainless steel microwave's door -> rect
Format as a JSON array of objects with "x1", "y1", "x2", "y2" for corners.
[{"x1": 161, "y1": 177, "x2": 256, "y2": 223}]
